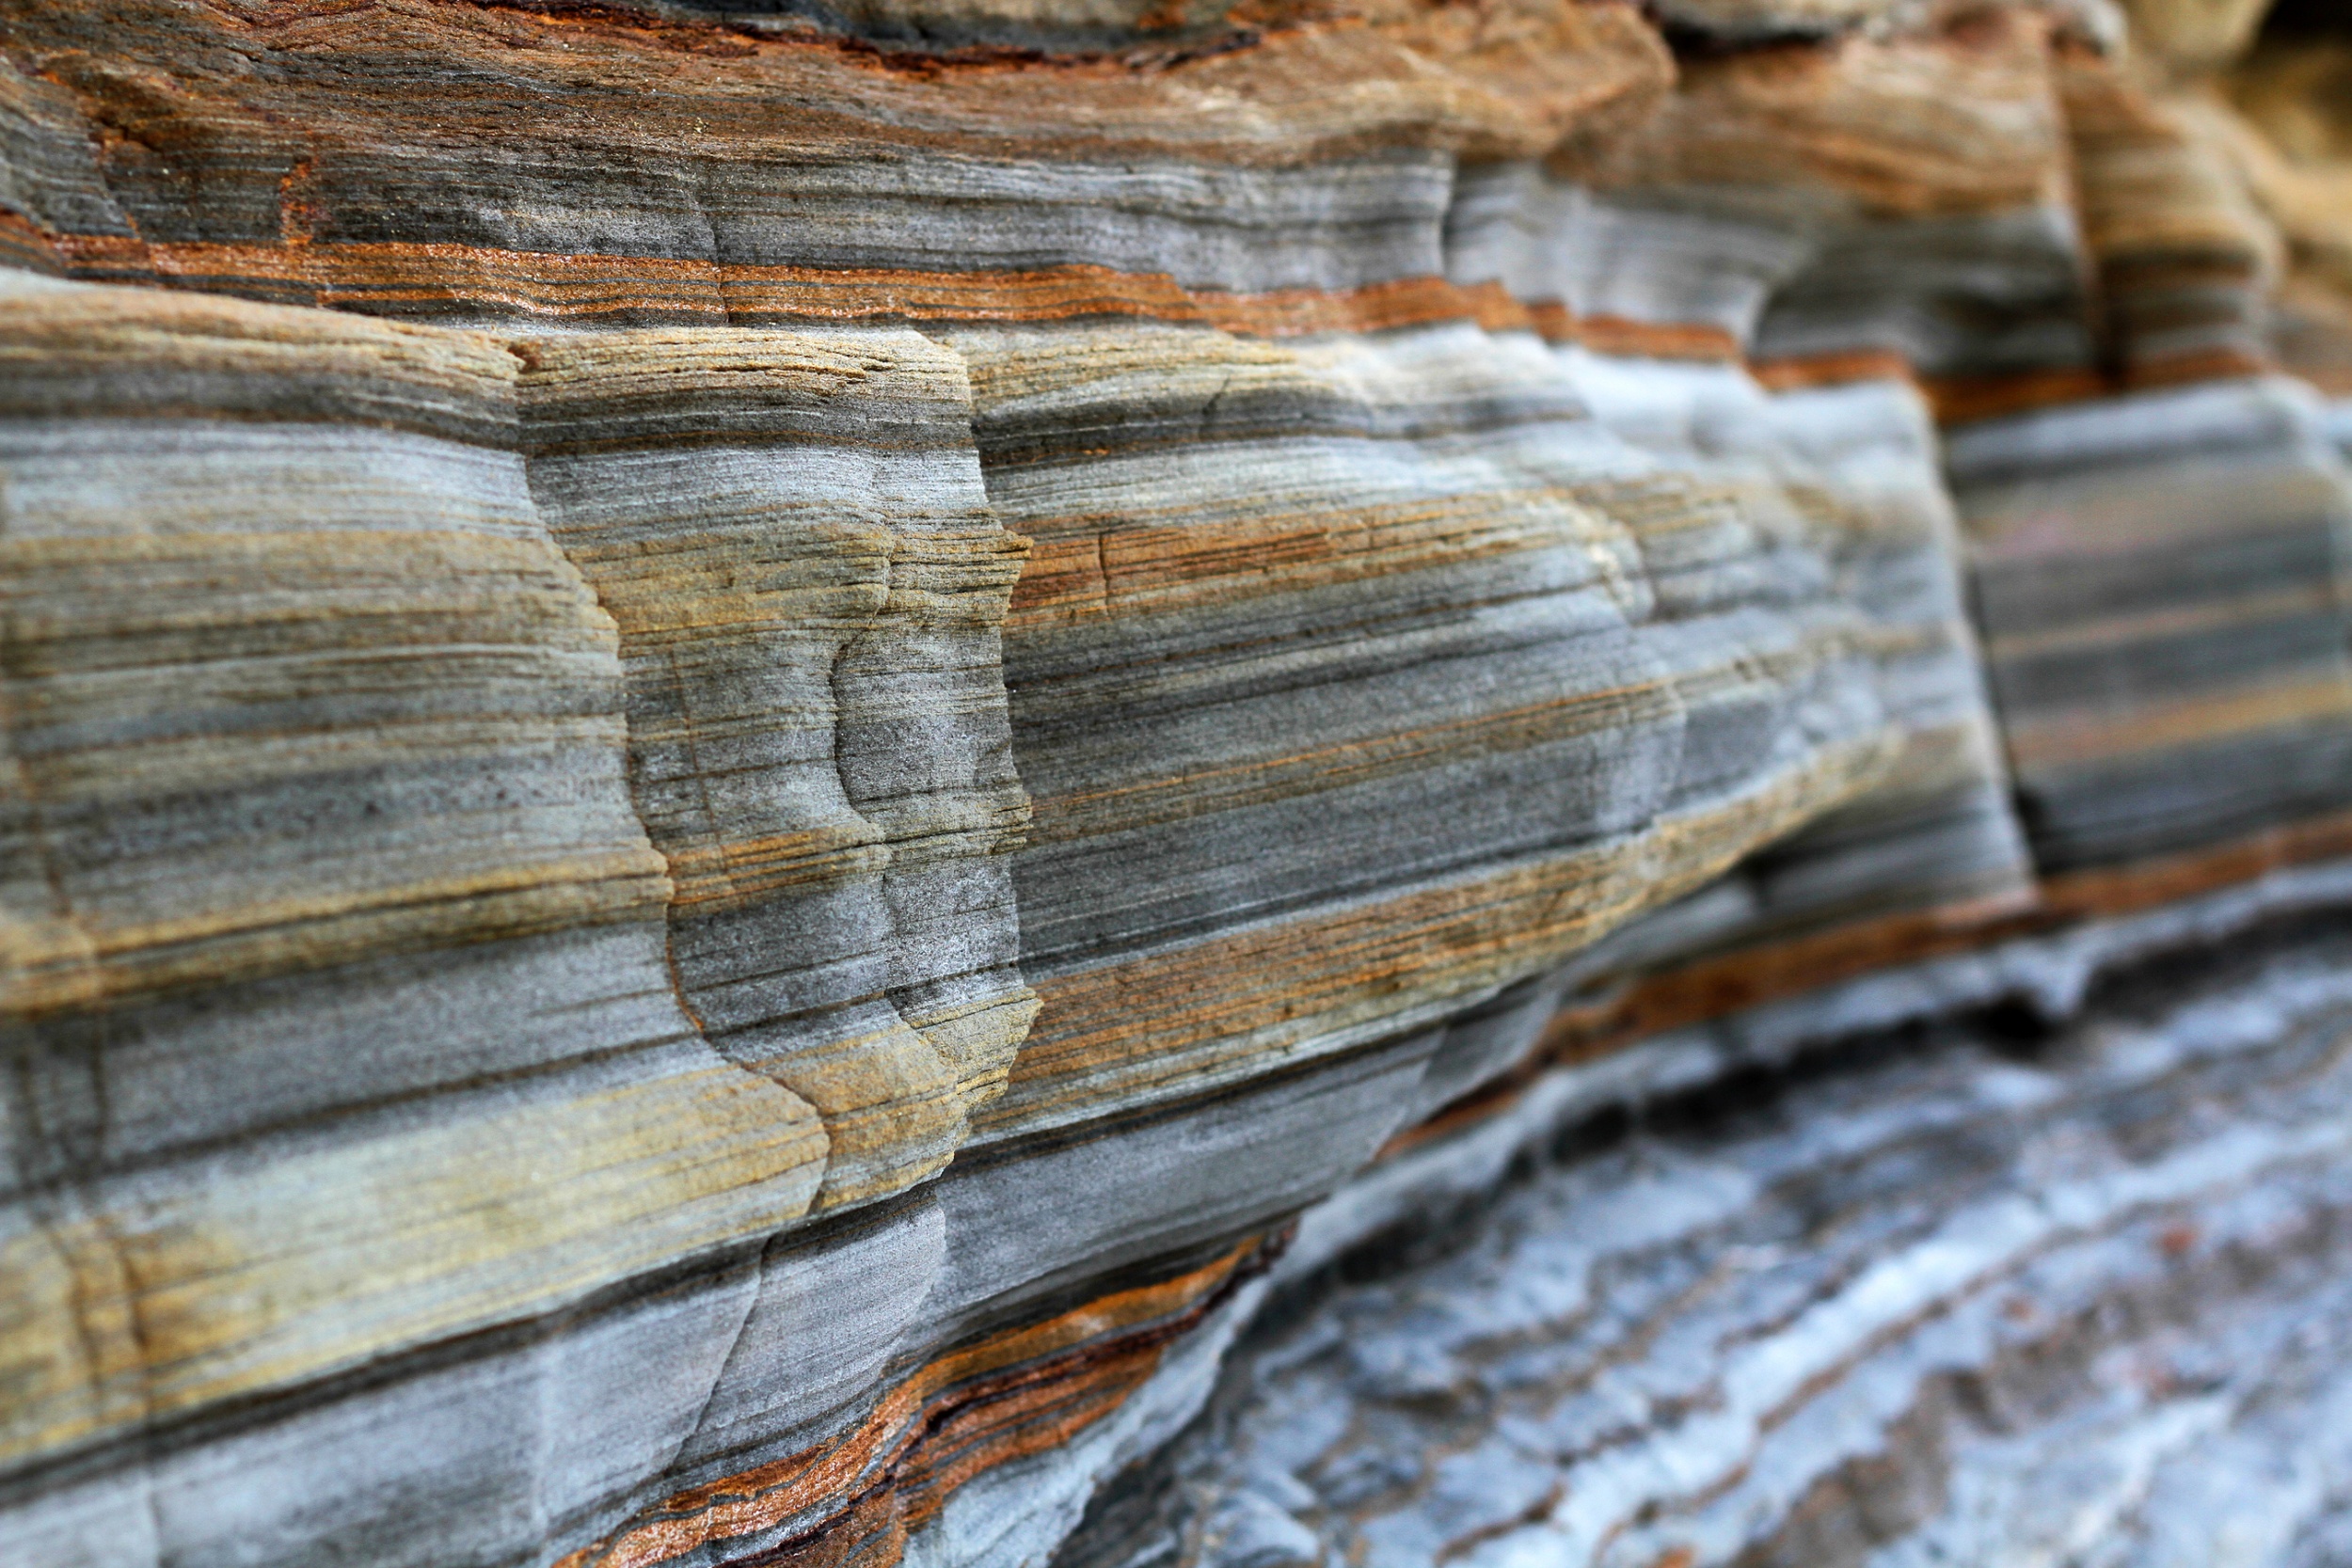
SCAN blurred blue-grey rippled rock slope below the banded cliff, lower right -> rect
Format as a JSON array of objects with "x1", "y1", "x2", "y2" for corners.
[{"x1": 1054, "y1": 936, "x2": 2352, "y2": 1568}]
